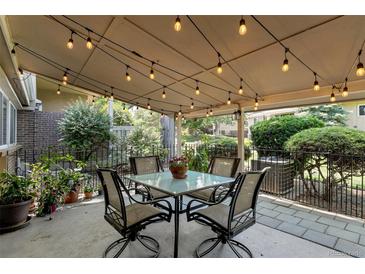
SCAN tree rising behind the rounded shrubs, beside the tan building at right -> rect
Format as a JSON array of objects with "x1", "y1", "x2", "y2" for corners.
[{"x1": 300, "y1": 104, "x2": 349, "y2": 126}]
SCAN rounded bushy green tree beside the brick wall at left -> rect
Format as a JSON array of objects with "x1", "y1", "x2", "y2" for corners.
[{"x1": 58, "y1": 100, "x2": 111, "y2": 151}]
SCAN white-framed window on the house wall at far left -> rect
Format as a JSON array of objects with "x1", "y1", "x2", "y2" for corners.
[{"x1": 0, "y1": 92, "x2": 16, "y2": 147}]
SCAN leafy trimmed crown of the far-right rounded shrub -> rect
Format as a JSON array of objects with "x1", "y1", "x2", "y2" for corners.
[{"x1": 285, "y1": 126, "x2": 365, "y2": 155}]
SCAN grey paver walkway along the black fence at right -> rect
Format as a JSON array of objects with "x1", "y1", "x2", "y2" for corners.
[{"x1": 257, "y1": 194, "x2": 365, "y2": 257}]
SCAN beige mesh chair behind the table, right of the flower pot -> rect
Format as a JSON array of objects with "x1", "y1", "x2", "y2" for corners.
[{"x1": 188, "y1": 157, "x2": 241, "y2": 202}]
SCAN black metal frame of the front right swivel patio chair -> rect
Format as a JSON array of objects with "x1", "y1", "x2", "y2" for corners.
[{"x1": 186, "y1": 167, "x2": 270, "y2": 258}]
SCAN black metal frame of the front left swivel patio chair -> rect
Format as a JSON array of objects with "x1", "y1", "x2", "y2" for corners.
[{"x1": 97, "y1": 169, "x2": 172, "y2": 258}]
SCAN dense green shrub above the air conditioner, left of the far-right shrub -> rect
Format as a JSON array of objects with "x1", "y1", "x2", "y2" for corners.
[{"x1": 251, "y1": 115, "x2": 324, "y2": 153}]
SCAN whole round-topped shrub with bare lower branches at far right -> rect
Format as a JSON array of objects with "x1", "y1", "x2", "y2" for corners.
[{"x1": 285, "y1": 126, "x2": 365, "y2": 199}]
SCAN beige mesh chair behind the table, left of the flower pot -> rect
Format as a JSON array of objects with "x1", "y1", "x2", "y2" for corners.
[{"x1": 129, "y1": 156, "x2": 169, "y2": 200}]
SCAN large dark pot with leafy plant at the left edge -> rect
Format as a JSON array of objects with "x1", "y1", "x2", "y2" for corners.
[{"x1": 0, "y1": 171, "x2": 36, "y2": 231}]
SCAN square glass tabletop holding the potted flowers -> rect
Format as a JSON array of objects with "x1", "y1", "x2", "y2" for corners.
[{"x1": 125, "y1": 170, "x2": 234, "y2": 196}]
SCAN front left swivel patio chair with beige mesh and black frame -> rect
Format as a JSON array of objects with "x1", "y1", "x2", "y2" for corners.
[{"x1": 97, "y1": 169, "x2": 172, "y2": 258}]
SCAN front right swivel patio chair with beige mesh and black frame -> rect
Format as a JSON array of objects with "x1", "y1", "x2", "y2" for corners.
[{"x1": 186, "y1": 167, "x2": 270, "y2": 258}]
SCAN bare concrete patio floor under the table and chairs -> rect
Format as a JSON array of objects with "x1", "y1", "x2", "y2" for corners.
[{"x1": 0, "y1": 199, "x2": 347, "y2": 258}]
